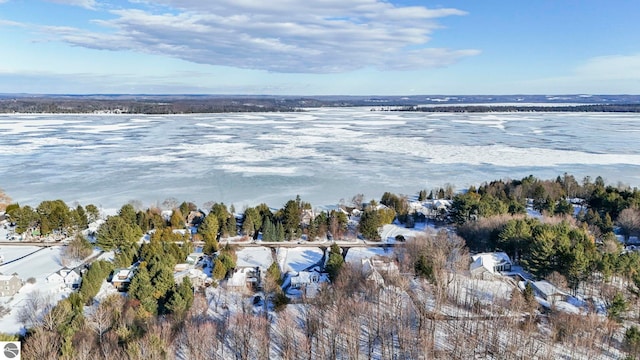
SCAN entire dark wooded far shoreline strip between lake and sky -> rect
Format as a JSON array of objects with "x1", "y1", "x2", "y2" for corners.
[{"x1": 0, "y1": 94, "x2": 640, "y2": 115}]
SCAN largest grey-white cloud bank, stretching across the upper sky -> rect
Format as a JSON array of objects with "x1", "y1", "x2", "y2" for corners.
[{"x1": 40, "y1": 0, "x2": 479, "y2": 73}]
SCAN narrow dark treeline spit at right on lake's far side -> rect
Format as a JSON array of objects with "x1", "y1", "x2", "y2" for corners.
[{"x1": 390, "y1": 104, "x2": 640, "y2": 113}]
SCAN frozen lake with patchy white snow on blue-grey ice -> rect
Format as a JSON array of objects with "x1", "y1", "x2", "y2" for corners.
[{"x1": 0, "y1": 108, "x2": 640, "y2": 209}]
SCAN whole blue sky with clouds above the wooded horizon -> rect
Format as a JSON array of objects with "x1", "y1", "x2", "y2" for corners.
[{"x1": 0, "y1": 0, "x2": 640, "y2": 96}]
